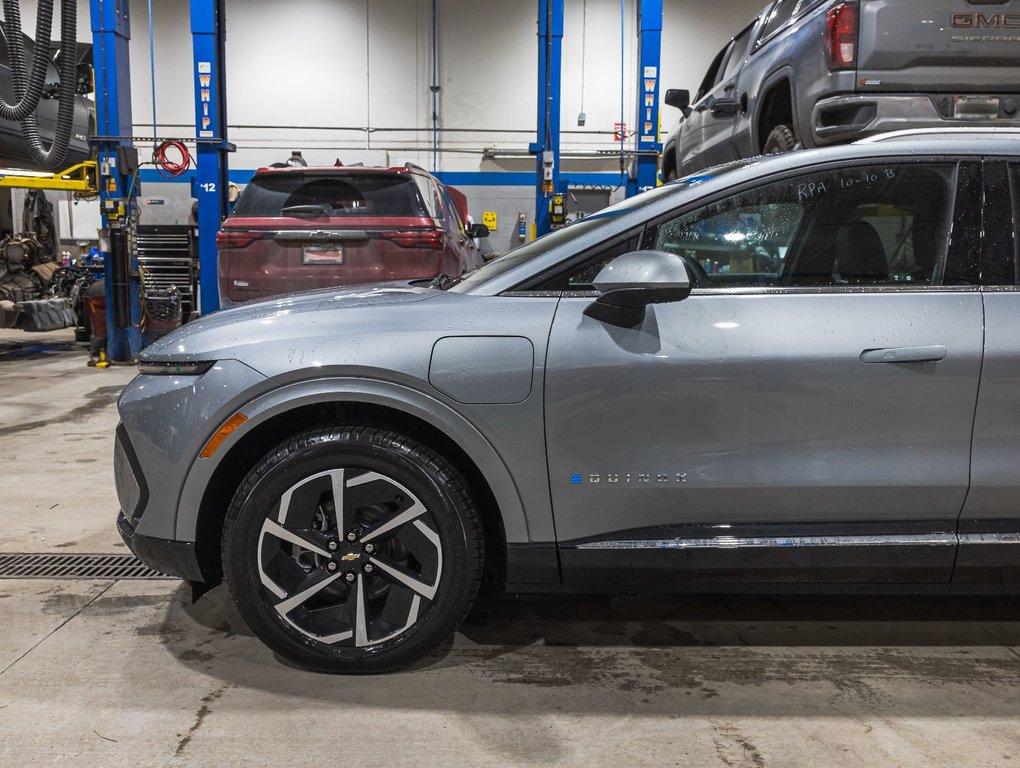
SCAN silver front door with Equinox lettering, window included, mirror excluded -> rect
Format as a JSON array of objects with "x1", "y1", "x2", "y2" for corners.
[{"x1": 546, "y1": 156, "x2": 982, "y2": 588}]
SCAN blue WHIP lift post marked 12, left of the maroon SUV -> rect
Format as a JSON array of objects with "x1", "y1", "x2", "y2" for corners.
[{"x1": 191, "y1": 0, "x2": 233, "y2": 314}]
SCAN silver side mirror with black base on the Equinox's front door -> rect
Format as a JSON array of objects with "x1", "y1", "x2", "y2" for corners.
[{"x1": 584, "y1": 251, "x2": 692, "y2": 328}]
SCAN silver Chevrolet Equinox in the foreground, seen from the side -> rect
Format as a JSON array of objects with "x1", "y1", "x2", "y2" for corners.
[{"x1": 115, "y1": 131, "x2": 1020, "y2": 672}]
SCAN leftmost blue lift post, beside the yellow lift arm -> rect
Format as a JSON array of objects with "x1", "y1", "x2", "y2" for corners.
[{"x1": 90, "y1": 0, "x2": 142, "y2": 362}]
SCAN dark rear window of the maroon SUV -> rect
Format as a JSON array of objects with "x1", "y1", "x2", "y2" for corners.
[{"x1": 234, "y1": 172, "x2": 429, "y2": 217}]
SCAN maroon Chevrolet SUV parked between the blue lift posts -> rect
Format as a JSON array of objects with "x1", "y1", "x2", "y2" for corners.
[{"x1": 216, "y1": 164, "x2": 489, "y2": 306}]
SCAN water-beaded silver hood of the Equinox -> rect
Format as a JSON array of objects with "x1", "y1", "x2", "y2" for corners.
[{"x1": 139, "y1": 283, "x2": 443, "y2": 362}]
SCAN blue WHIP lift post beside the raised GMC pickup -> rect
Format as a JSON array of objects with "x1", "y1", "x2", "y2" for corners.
[{"x1": 627, "y1": 0, "x2": 662, "y2": 197}]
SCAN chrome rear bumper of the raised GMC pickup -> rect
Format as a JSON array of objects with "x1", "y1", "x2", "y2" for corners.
[{"x1": 811, "y1": 94, "x2": 1020, "y2": 147}]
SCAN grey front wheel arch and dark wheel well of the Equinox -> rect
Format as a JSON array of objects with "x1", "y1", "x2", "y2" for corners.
[{"x1": 183, "y1": 379, "x2": 529, "y2": 583}]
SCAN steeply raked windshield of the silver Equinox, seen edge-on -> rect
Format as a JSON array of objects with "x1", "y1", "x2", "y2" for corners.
[{"x1": 449, "y1": 160, "x2": 748, "y2": 293}]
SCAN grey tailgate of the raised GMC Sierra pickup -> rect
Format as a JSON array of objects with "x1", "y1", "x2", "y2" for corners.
[{"x1": 857, "y1": 0, "x2": 1020, "y2": 93}]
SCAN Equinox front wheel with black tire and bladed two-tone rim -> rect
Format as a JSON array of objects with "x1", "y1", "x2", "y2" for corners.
[{"x1": 222, "y1": 425, "x2": 483, "y2": 674}]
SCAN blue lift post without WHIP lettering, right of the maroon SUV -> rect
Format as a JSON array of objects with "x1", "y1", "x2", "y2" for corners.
[{"x1": 529, "y1": 0, "x2": 565, "y2": 238}]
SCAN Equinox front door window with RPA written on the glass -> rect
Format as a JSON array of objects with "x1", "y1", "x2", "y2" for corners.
[{"x1": 652, "y1": 164, "x2": 956, "y2": 288}]
